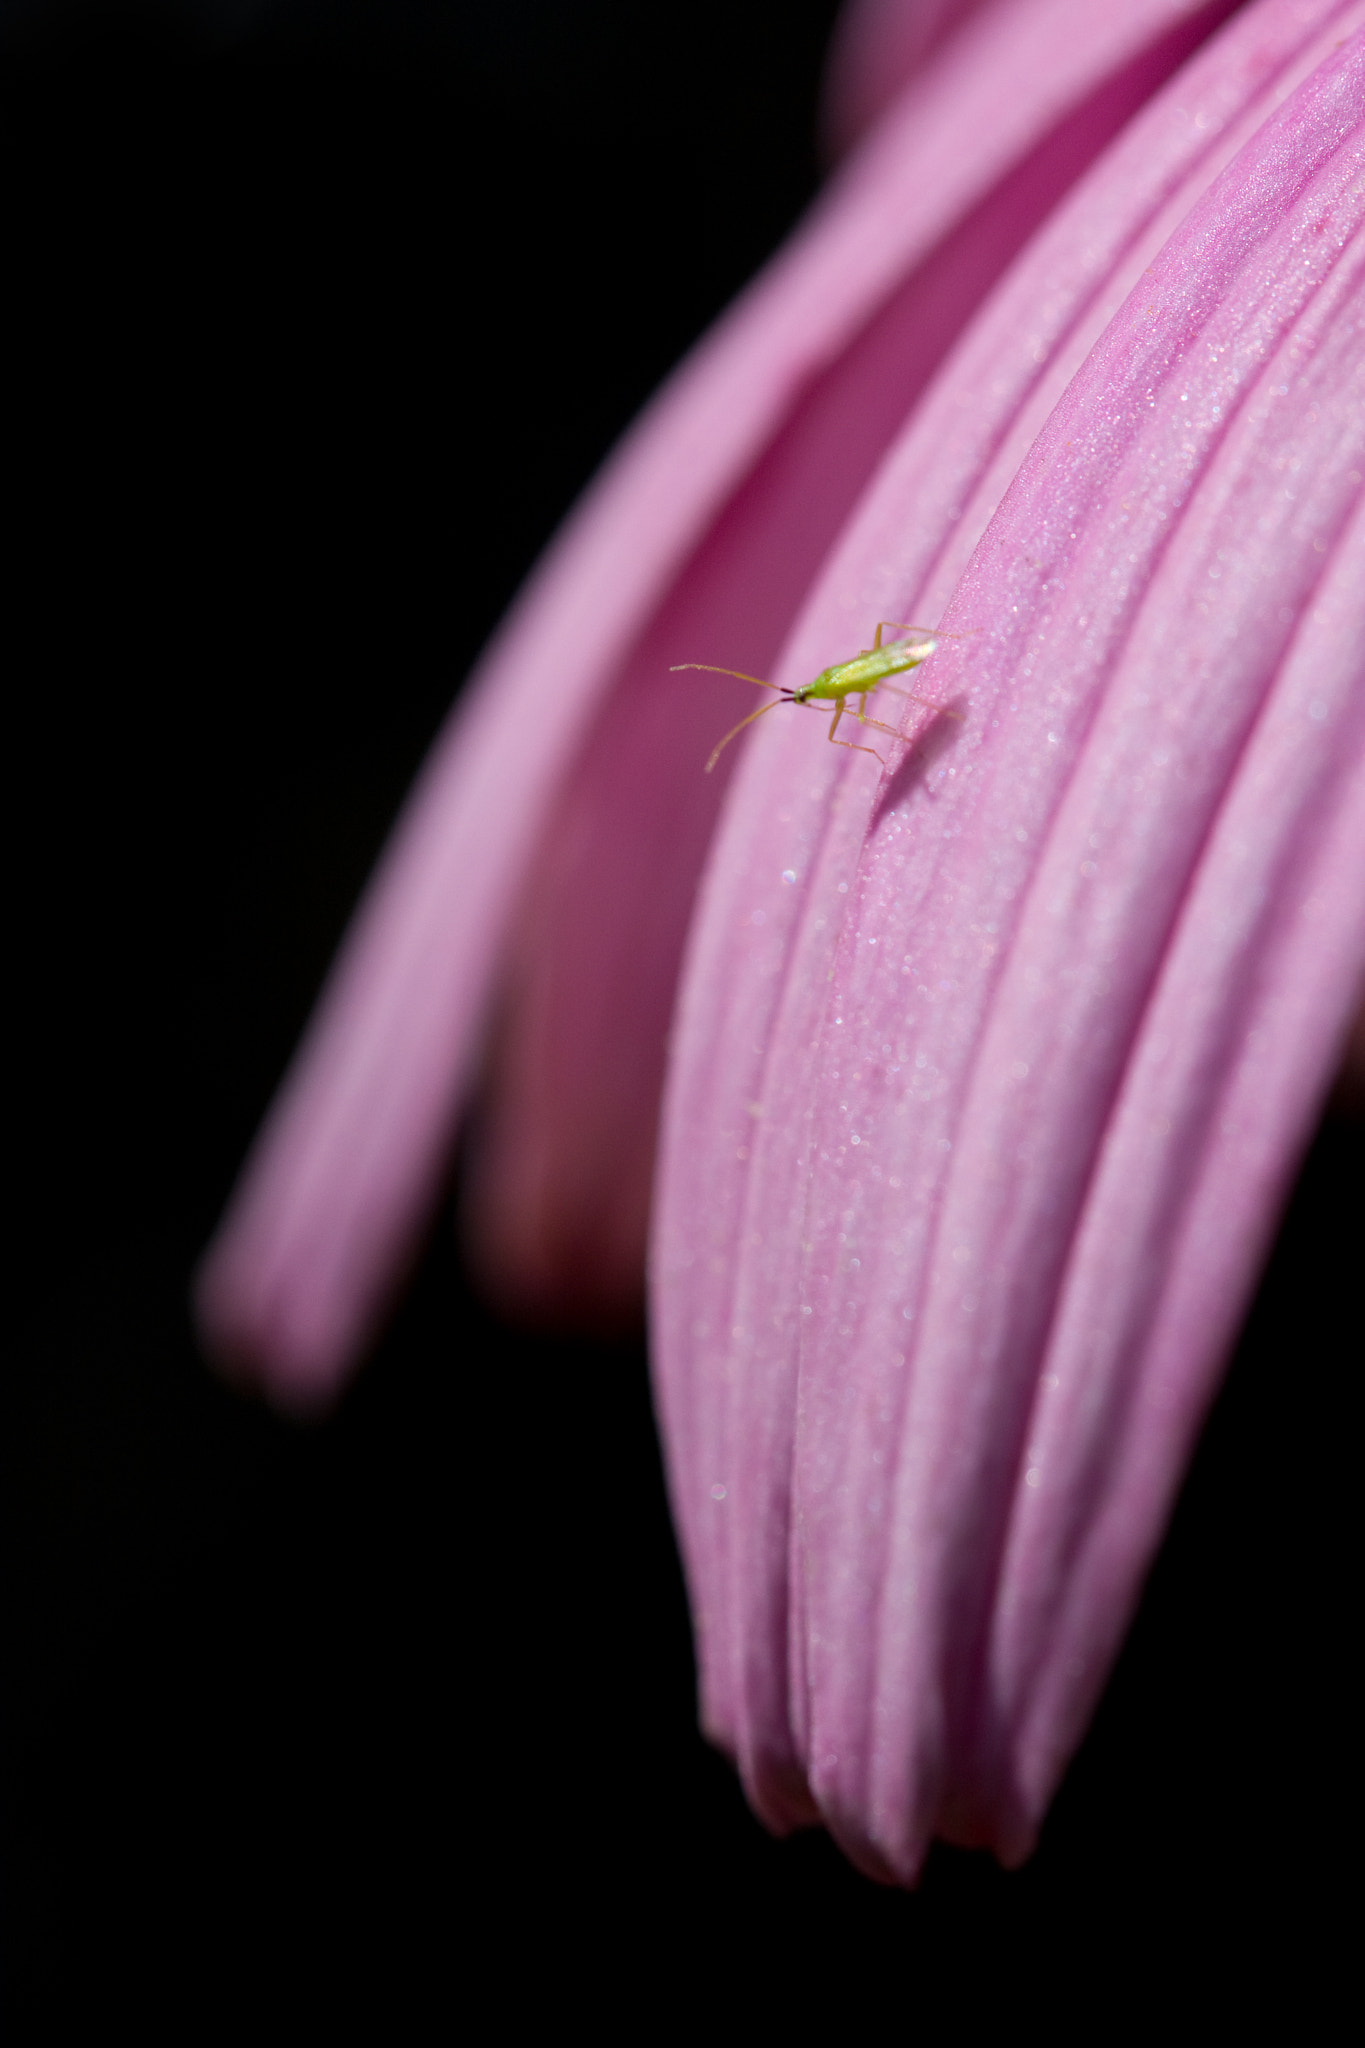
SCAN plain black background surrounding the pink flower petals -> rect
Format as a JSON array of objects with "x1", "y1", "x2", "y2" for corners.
[{"x1": 0, "y1": 0, "x2": 1365, "y2": 2015}]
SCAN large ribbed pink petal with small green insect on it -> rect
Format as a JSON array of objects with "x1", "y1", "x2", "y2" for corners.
[{"x1": 655, "y1": 4, "x2": 1365, "y2": 1878}]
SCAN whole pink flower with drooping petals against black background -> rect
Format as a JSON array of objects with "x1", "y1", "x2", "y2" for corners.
[{"x1": 201, "y1": 0, "x2": 1365, "y2": 1882}]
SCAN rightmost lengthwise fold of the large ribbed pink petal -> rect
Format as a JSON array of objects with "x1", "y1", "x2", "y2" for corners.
[{"x1": 986, "y1": 499, "x2": 1365, "y2": 1853}]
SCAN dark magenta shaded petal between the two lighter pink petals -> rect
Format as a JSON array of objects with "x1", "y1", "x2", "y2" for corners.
[{"x1": 465, "y1": 0, "x2": 1236, "y2": 1321}]
